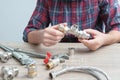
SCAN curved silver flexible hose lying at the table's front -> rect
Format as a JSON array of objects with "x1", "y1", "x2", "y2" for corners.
[{"x1": 49, "y1": 66, "x2": 110, "y2": 80}]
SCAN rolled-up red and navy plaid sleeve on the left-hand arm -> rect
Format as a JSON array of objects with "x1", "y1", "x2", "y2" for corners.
[{"x1": 23, "y1": 0, "x2": 50, "y2": 42}]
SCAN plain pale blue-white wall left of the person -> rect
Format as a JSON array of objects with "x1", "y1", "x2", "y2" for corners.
[{"x1": 0, "y1": 0, "x2": 37, "y2": 42}]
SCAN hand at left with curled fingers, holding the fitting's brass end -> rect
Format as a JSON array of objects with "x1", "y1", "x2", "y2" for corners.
[{"x1": 42, "y1": 23, "x2": 66, "y2": 46}]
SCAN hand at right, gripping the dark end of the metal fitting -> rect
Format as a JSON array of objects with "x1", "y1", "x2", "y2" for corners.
[{"x1": 78, "y1": 29, "x2": 107, "y2": 50}]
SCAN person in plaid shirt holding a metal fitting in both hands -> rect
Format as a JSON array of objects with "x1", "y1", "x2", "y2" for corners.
[{"x1": 23, "y1": 0, "x2": 120, "y2": 50}]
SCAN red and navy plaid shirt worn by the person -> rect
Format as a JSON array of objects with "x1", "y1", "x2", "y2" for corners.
[{"x1": 23, "y1": 0, "x2": 120, "y2": 42}]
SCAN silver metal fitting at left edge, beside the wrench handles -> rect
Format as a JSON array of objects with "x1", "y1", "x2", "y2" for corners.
[{"x1": 0, "y1": 51, "x2": 12, "y2": 63}]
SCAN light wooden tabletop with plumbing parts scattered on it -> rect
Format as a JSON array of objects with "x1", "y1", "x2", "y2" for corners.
[{"x1": 0, "y1": 42, "x2": 120, "y2": 80}]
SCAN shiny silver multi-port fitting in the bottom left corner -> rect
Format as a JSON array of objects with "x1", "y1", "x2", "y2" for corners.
[{"x1": 1, "y1": 67, "x2": 19, "y2": 80}]
